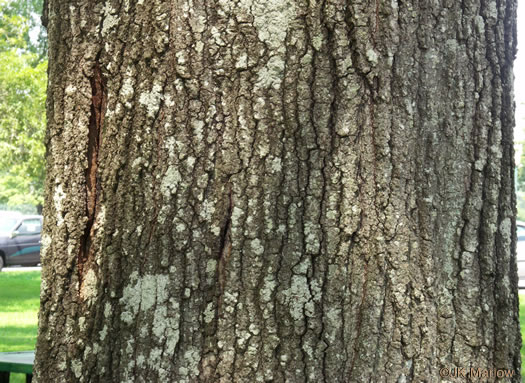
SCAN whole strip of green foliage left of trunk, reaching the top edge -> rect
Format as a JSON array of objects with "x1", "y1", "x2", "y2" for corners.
[{"x1": 0, "y1": 0, "x2": 47, "y2": 206}]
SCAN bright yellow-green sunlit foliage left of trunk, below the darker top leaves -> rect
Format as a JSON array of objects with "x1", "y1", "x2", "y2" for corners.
[{"x1": 0, "y1": 50, "x2": 47, "y2": 205}]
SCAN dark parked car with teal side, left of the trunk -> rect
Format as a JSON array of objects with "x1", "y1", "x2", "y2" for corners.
[{"x1": 0, "y1": 211, "x2": 42, "y2": 270}]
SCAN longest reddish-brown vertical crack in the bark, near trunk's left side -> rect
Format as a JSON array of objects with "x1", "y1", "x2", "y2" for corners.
[{"x1": 77, "y1": 61, "x2": 107, "y2": 292}]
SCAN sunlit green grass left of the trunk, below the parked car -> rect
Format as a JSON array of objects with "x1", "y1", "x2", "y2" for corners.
[{"x1": 0, "y1": 271, "x2": 40, "y2": 383}]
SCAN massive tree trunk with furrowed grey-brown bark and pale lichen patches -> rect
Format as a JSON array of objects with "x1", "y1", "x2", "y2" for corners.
[{"x1": 36, "y1": 0, "x2": 521, "y2": 383}]
